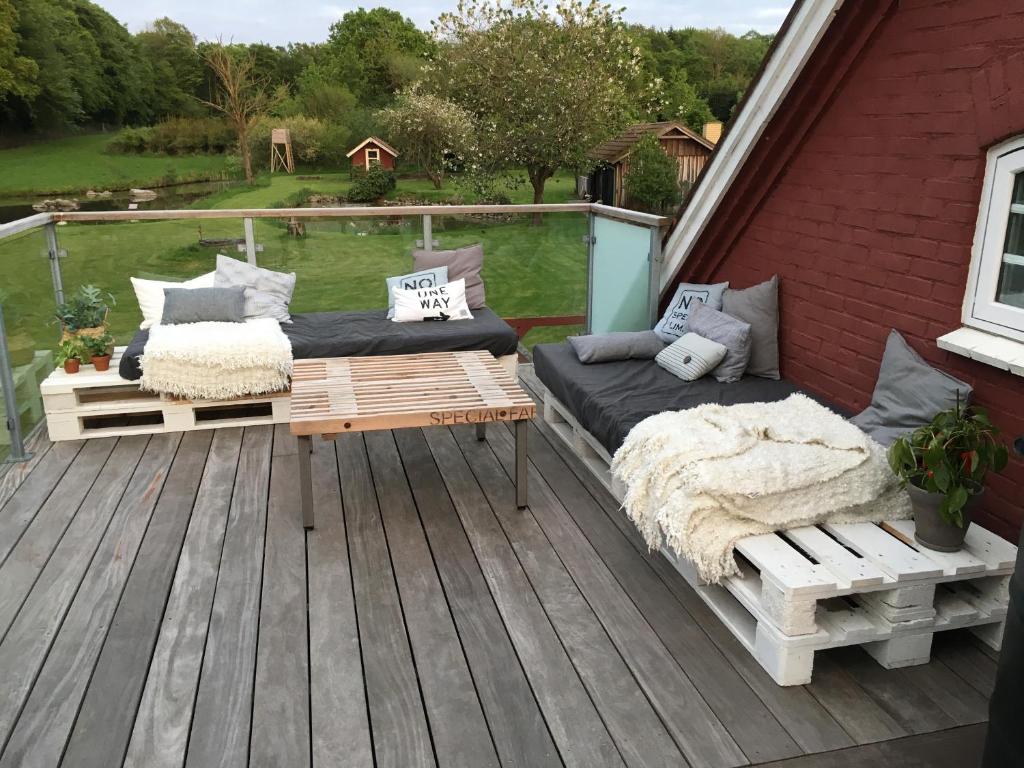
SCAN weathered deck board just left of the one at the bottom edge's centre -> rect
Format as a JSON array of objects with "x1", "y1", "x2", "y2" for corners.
[{"x1": 366, "y1": 432, "x2": 498, "y2": 768}]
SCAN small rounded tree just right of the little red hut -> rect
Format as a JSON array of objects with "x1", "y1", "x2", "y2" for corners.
[{"x1": 377, "y1": 90, "x2": 473, "y2": 189}]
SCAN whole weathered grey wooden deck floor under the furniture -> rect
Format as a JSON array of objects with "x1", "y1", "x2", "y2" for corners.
[{"x1": 0, "y1": 374, "x2": 995, "y2": 768}]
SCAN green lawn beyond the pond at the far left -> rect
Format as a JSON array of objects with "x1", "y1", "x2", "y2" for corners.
[{"x1": 0, "y1": 133, "x2": 234, "y2": 198}]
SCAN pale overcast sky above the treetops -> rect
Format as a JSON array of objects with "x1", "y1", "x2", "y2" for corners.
[{"x1": 93, "y1": 0, "x2": 792, "y2": 44}]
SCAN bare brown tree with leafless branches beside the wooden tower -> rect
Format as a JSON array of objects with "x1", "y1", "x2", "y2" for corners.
[{"x1": 204, "y1": 43, "x2": 270, "y2": 184}]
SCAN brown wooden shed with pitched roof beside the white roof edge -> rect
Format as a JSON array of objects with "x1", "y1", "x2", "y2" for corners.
[{"x1": 590, "y1": 121, "x2": 715, "y2": 206}]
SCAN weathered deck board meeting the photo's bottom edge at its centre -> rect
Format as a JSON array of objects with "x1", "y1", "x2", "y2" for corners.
[{"x1": 395, "y1": 429, "x2": 562, "y2": 768}]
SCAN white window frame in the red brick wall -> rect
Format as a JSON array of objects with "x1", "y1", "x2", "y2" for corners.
[{"x1": 963, "y1": 136, "x2": 1024, "y2": 341}]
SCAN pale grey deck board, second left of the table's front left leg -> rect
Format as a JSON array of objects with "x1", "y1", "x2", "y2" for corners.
[{"x1": 185, "y1": 427, "x2": 272, "y2": 768}]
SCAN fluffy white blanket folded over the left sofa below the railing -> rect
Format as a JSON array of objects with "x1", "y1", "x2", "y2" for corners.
[{"x1": 139, "y1": 318, "x2": 292, "y2": 400}]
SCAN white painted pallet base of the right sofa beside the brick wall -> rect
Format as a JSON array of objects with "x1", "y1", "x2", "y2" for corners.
[{"x1": 541, "y1": 385, "x2": 1017, "y2": 685}]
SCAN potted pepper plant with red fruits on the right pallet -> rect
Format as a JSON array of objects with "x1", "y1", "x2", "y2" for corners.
[{"x1": 889, "y1": 402, "x2": 1010, "y2": 552}]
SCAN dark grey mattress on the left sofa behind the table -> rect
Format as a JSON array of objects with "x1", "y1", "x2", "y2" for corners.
[{"x1": 119, "y1": 307, "x2": 519, "y2": 381}]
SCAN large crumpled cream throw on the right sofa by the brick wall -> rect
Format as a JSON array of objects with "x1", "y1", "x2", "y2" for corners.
[{"x1": 612, "y1": 394, "x2": 910, "y2": 583}]
